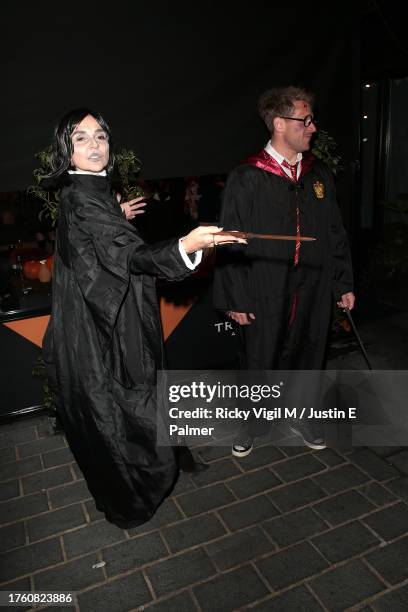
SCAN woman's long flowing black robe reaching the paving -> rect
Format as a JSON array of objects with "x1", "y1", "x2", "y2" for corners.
[{"x1": 43, "y1": 175, "x2": 190, "y2": 528}]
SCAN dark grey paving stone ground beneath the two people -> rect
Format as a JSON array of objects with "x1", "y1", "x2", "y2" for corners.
[{"x1": 0, "y1": 416, "x2": 408, "y2": 612}]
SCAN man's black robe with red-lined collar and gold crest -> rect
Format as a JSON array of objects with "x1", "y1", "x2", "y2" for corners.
[{"x1": 214, "y1": 150, "x2": 353, "y2": 370}]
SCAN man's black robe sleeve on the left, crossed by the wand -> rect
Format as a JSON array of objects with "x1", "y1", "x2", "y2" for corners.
[{"x1": 213, "y1": 166, "x2": 254, "y2": 312}]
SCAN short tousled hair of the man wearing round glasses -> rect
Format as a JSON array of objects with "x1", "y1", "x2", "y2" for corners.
[{"x1": 258, "y1": 85, "x2": 314, "y2": 134}]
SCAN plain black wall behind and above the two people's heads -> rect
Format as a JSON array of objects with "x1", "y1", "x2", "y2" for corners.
[{"x1": 0, "y1": 0, "x2": 358, "y2": 191}]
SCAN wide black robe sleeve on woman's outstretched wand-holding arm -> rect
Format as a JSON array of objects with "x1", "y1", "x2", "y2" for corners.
[{"x1": 68, "y1": 193, "x2": 191, "y2": 352}]
